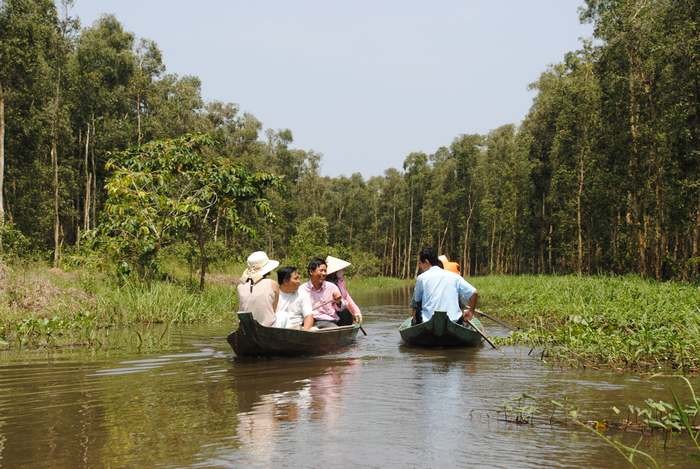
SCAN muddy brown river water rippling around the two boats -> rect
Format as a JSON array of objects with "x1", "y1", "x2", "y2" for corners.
[{"x1": 0, "y1": 291, "x2": 700, "y2": 468}]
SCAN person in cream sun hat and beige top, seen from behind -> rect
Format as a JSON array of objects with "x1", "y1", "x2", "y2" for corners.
[{"x1": 237, "y1": 251, "x2": 280, "y2": 326}]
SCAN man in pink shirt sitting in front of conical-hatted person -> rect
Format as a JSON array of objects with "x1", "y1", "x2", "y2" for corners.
[{"x1": 301, "y1": 257, "x2": 346, "y2": 329}]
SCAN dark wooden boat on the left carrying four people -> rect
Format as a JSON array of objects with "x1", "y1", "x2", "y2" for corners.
[{"x1": 226, "y1": 312, "x2": 360, "y2": 357}]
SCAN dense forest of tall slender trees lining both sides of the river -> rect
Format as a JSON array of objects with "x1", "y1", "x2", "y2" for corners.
[{"x1": 0, "y1": 0, "x2": 700, "y2": 280}]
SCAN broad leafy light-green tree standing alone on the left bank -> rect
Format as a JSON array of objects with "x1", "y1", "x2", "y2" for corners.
[{"x1": 100, "y1": 134, "x2": 276, "y2": 284}]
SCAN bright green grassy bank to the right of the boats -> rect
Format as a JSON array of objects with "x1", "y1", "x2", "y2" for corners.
[{"x1": 473, "y1": 275, "x2": 700, "y2": 371}]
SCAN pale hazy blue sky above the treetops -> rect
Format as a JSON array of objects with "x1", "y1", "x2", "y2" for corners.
[{"x1": 72, "y1": 0, "x2": 592, "y2": 177}]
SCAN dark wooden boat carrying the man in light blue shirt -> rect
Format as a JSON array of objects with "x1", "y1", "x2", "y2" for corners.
[{"x1": 399, "y1": 311, "x2": 481, "y2": 347}]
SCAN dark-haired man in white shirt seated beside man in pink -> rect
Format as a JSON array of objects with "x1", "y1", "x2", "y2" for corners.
[{"x1": 274, "y1": 266, "x2": 314, "y2": 331}]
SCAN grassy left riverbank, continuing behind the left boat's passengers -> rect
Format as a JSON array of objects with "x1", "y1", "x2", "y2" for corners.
[{"x1": 0, "y1": 263, "x2": 412, "y2": 349}]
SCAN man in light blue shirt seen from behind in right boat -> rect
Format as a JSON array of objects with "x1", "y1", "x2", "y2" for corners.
[{"x1": 411, "y1": 247, "x2": 479, "y2": 324}]
